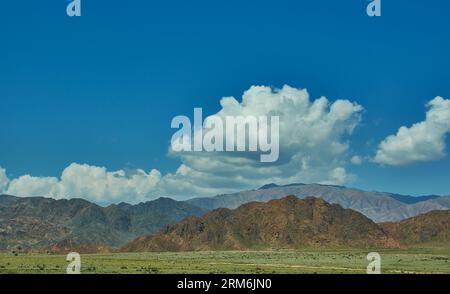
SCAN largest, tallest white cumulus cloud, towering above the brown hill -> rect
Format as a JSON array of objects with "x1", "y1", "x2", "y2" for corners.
[{"x1": 164, "y1": 86, "x2": 363, "y2": 194}]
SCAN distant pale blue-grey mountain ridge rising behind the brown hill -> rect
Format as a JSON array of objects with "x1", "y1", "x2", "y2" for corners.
[{"x1": 187, "y1": 184, "x2": 450, "y2": 222}]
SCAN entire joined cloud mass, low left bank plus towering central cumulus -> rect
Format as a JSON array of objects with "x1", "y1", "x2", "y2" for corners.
[{"x1": 1, "y1": 86, "x2": 363, "y2": 203}]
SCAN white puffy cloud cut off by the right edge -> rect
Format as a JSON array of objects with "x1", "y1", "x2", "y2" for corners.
[{"x1": 374, "y1": 97, "x2": 450, "y2": 166}]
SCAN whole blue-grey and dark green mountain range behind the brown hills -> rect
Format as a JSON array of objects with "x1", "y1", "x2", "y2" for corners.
[{"x1": 0, "y1": 184, "x2": 450, "y2": 251}]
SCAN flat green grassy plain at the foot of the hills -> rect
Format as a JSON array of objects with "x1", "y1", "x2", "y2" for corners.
[{"x1": 0, "y1": 248, "x2": 450, "y2": 274}]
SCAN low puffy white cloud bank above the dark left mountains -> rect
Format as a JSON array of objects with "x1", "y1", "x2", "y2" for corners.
[{"x1": 7, "y1": 163, "x2": 161, "y2": 203}]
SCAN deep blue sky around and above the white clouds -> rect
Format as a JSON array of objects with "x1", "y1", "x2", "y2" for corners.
[{"x1": 0, "y1": 0, "x2": 450, "y2": 202}]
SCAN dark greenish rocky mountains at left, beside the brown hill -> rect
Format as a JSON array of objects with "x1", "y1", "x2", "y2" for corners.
[{"x1": 0, "y1": 195, "x2": 206, "y2": 251}]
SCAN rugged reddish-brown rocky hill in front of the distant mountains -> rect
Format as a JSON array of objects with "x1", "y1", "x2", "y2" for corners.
[{"x1": 123, "y1": 196, "x2": 398, "y2": 251}]
